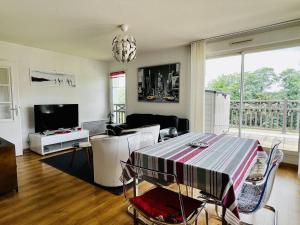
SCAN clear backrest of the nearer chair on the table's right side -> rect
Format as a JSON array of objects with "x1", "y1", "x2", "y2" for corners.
[{"x1": 253, "y1": 150, "x2": 283, "y2": 211}]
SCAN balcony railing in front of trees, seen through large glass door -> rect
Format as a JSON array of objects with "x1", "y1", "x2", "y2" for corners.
[{"x1": 230, "y1": 100, "x2": 300, "y2": 133}]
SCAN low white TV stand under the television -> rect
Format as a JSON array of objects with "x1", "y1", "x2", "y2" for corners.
[{"x1": 29, "y1": 130, "x2": 89, "y2": 155}]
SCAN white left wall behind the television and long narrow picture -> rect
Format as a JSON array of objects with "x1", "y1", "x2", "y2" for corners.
[{"x1": 0, "y1": 42, "x2": 108, "y2": 148}]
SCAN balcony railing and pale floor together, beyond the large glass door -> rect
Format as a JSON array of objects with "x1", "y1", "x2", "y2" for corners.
[{"x1": 229, "y1": 100, "x2": 300, "y2": 152}]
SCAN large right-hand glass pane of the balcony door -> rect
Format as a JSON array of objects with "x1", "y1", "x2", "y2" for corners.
[{"x1": 241, "y1": 47, "x2": 300, "y2": 152}]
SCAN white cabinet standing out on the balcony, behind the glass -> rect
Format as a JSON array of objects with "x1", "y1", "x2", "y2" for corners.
[{"x1": 205, "y1": 90, "x2": 230, "y2": 134}]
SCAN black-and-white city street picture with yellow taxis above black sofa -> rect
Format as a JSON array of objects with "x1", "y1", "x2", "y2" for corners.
[{"x1": 138, "y1": 63, "x2": 180, "y2": 103}]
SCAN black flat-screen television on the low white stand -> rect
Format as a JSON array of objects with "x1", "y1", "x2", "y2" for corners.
[{"x1": 34, "y1": 104, "x2": 78, "y2": 133}]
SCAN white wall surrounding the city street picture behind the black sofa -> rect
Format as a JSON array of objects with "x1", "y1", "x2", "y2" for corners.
[{"x1": 109, "y1": 46, "x2": 191, "y2": 118}]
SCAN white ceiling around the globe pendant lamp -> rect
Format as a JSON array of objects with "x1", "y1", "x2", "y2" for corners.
[{"x1": 0, "y1": 0, "x2": 300, "y2": 60}]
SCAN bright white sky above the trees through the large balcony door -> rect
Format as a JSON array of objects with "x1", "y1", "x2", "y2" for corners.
[{"x1": 205, "y1": 47, "x2": 300, "y2": 86}]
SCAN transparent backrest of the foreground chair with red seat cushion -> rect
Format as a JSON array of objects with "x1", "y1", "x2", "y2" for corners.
[{"x1": 120, "y1": 161, "x2": 186, "y2": 224}]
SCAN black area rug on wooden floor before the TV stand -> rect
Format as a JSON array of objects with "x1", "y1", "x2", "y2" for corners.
[{"x1": 41, "y1": 150, "x2": 123, "y2": 195}]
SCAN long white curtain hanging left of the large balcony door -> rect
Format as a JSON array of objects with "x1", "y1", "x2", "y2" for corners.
[{"x1": 190, "y1": 40, "x2": 206, "y2": 132}]
